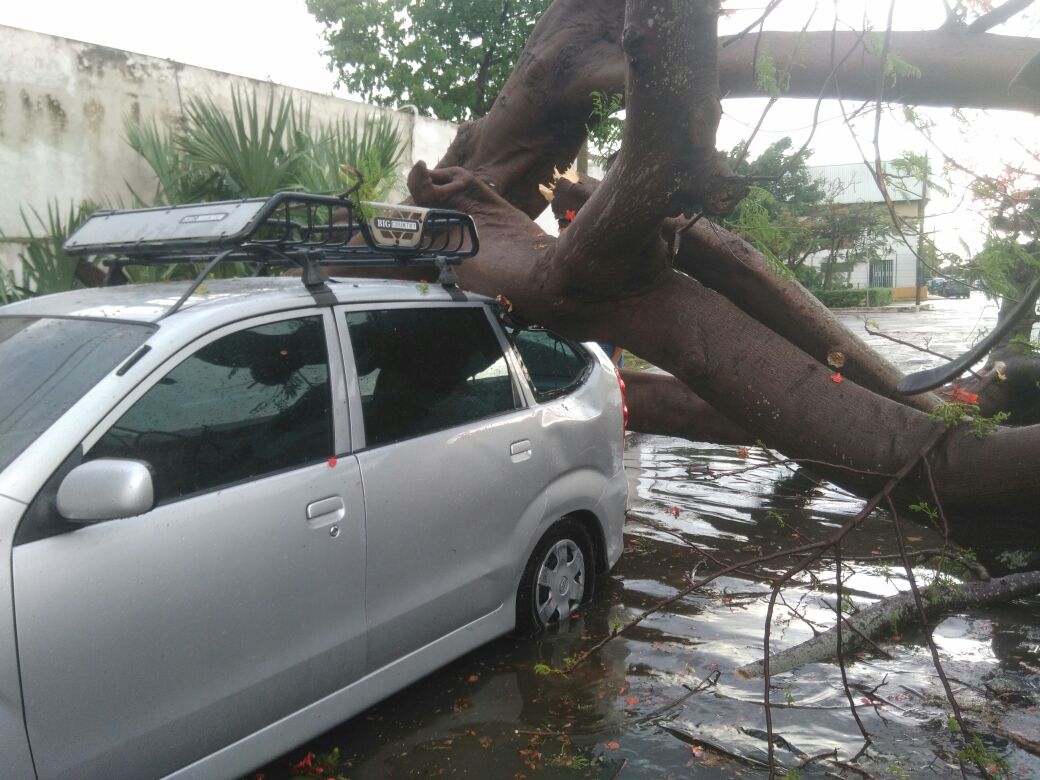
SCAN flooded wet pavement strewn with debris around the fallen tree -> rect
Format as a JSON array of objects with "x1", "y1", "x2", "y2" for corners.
[{"x1": 253, "y1": 293, "x2": 1040, "y2": 780}]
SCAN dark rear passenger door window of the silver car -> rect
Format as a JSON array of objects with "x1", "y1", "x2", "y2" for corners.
[{"x1": 345, "y1": 307, "x2": 519, "y2": 446}]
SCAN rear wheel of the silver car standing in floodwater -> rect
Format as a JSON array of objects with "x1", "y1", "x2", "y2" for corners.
[{"x1": 517, "y1": 518, "x2": 596, "y2": 635}]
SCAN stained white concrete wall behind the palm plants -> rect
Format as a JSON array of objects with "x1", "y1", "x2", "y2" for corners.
[{"x1": 0, "y1": 25, "x2": 463, "y2": 267}]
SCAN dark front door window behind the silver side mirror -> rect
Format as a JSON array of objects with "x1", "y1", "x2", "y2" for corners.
[{"x1": 87, "y1": 316, "x2": 334, "y2": 501}]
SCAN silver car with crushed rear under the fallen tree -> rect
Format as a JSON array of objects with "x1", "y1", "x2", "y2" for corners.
[{"x1": 0, "y1": 278, "x2": 627, "y2": 780}]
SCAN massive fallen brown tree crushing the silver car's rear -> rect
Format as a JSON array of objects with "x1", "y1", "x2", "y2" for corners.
[{"x1": 409, "y1": 0, "x2": 1040, "y2": 569}]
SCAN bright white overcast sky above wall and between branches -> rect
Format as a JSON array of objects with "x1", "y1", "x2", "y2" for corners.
[{"x1": 0, "y1": 0, "x2": 1040, "y2": 250}]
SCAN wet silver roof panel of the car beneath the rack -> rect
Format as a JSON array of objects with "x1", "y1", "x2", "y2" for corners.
[{"x1": 0, "y1": 277, "x2": 488, "y2": 322}]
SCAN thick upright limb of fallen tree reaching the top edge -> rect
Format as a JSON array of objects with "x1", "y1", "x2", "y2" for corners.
[{"x1": 557, "y1": 0, "x2": 743, "y2": 300}]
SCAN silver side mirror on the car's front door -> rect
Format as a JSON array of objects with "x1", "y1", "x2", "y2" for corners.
[{"x1": 57, "y1": 458, "x2": 155, "y2": 523}]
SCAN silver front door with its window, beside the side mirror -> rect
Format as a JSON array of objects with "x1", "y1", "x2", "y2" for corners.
[{"x1": 12, "y1": 309, "x2": 365, "y2": 779}]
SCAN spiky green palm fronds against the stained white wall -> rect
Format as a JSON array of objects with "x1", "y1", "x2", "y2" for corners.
[{"x1": 9, "y1": 92, "x2": 402, "y2": 303}]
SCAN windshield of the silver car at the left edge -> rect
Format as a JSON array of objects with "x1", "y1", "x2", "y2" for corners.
[{"x1": 0, "y1": 317, "x2": 153, "y2": 470}]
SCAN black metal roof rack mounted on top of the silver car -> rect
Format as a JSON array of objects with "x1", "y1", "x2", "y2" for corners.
[{"x1": 64, "y1": 192, "x2": 479, "y2": 284}]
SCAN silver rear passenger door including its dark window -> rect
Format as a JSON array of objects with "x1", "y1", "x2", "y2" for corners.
[{"x1": 341, "y1": 305, "x2": 550, "y2": 669}]
